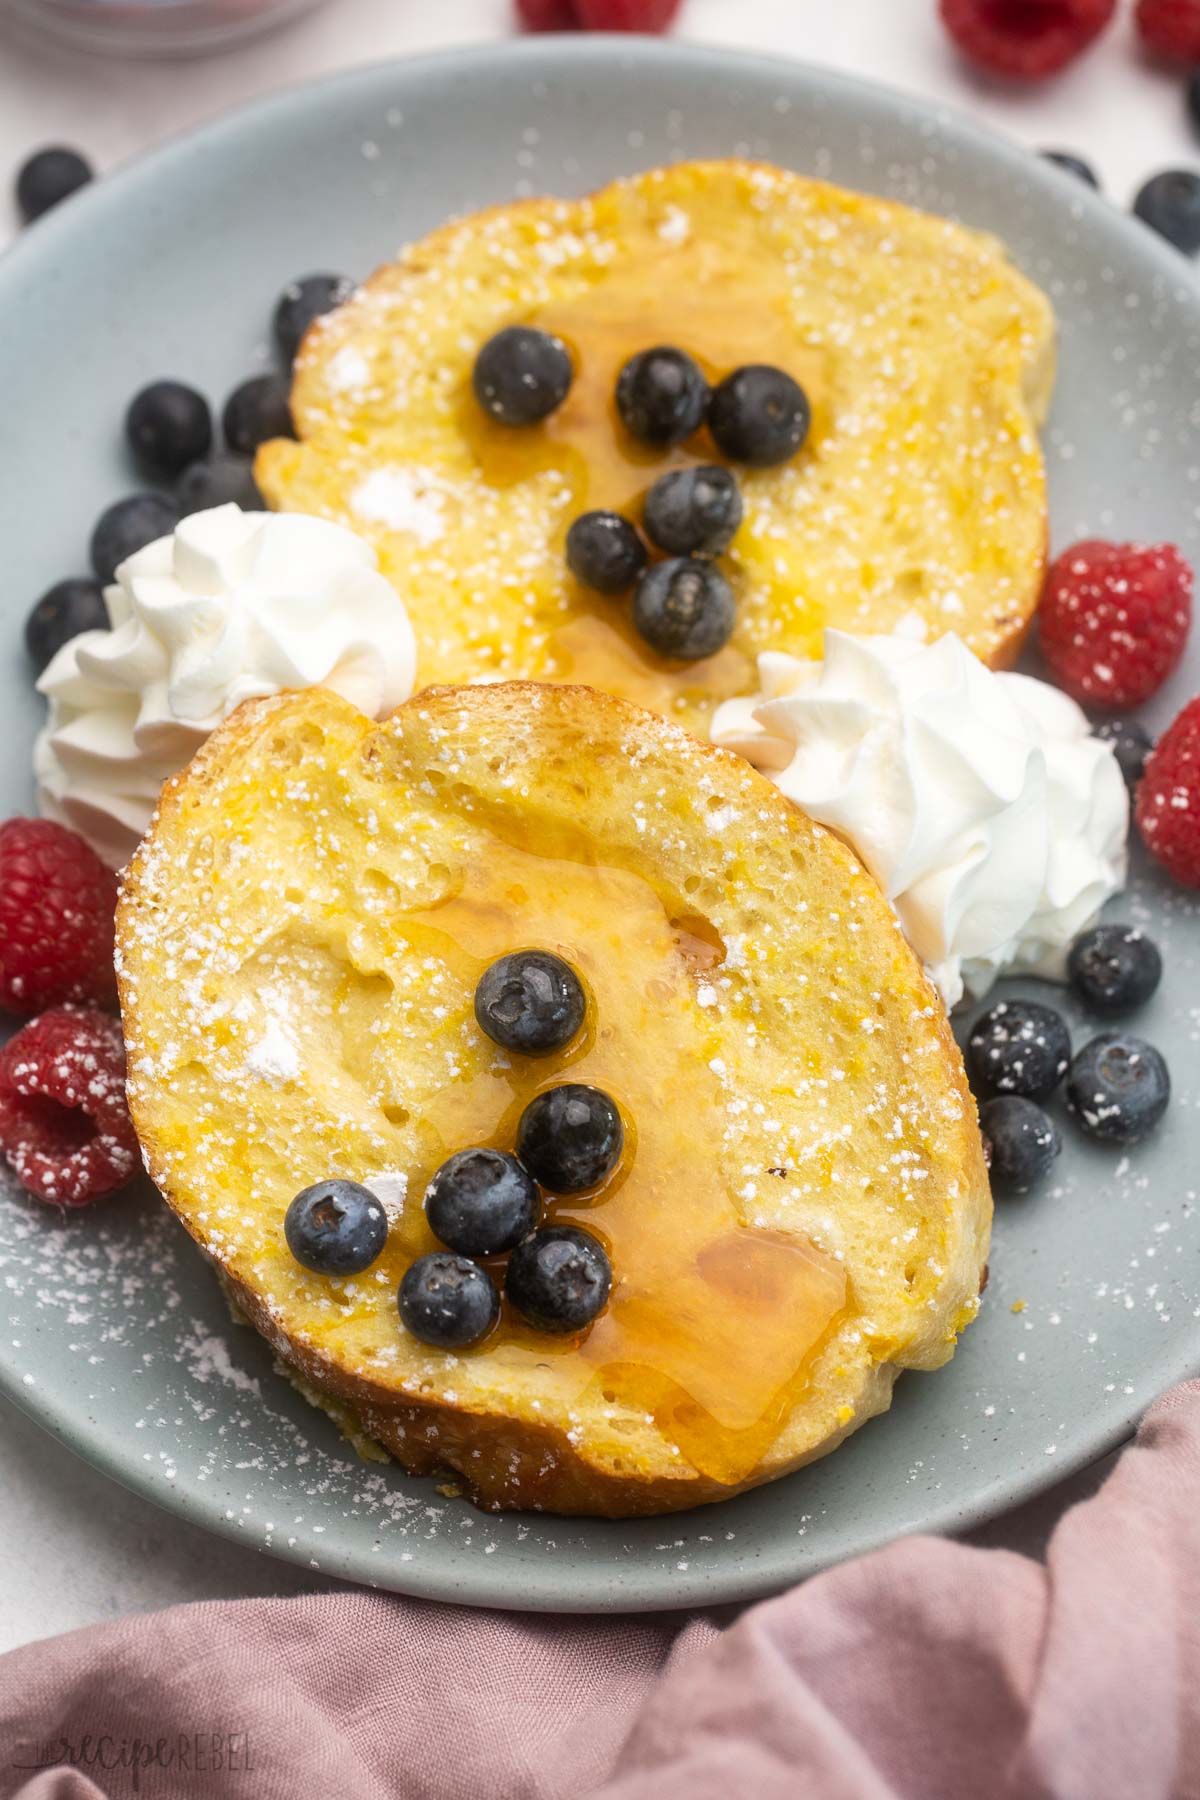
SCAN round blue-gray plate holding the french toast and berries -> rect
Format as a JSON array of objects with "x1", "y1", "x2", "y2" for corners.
[{"x1": 0, "y1": 40, "x2": 1200, "y2": 1611}]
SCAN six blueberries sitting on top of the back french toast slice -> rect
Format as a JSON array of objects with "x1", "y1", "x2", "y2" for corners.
[{"x1": 473, "y1": 326, "x2": 811, "y2": 662}]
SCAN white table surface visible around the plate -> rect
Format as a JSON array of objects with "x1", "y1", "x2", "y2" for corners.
[{"x1": 0, "y1": 0, "x2": 1200, "y2": 1651}]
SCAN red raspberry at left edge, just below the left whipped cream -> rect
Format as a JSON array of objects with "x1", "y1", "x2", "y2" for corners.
[{"x1": 0, "y1": 819, "x2": 117, "y2": 1015}]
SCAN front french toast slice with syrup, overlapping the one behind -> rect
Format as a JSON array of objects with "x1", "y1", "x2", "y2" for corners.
[{"x1": 119, "y1": 684, "x2": 991, "y2": 1516}]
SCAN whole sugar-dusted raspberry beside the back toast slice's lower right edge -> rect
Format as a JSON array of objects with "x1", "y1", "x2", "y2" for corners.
[{"x1": 1038, "y1": 540, "x2": 1191, "y2": 711}]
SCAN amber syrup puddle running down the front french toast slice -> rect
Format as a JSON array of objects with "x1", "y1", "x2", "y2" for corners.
[{"x1": 394, "y1": 839, "x2": 847, "y2": 1485}]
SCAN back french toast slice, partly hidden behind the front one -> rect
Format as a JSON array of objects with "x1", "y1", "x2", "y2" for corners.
[{"x1": 255, "y1": 162, "x2": 1054, "y2": 734}]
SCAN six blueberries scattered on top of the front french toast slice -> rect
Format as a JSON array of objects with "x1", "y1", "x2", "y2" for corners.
[{"x1": 284, "y1": 950, "x2": 624, "y2": 1350}]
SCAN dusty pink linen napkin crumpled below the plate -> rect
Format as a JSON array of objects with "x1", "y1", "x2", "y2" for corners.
[{"x1": 0, "y1": 1381, "x2": 1200, "y2": 1800}]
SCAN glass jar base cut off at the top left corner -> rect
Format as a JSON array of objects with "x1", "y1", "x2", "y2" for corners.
[{"x1": 0, "y1": 0, "x2": 318, "y2": 56}]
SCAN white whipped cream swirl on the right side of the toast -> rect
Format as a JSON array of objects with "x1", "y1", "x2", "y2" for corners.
[{"x1": 712, "y1": 632, "x2": 1130, "y2": 1006}]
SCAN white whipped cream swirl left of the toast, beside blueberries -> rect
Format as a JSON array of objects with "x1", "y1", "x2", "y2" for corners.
[{"x1": 34, "y1": 506, "x2": 416, "y2": 868}]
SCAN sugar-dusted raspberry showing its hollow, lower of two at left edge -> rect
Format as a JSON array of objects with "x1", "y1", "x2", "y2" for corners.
[{"x1": 0, "y1": 1006, "x2": 139, "y2": 1206}]
